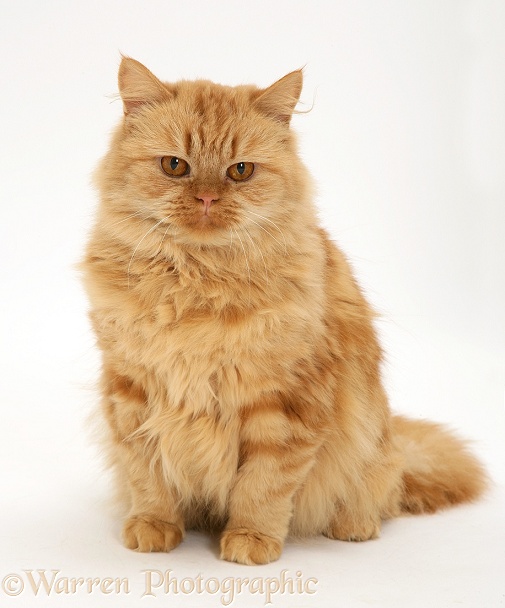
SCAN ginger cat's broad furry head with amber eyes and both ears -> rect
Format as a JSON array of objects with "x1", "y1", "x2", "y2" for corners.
[{"x1": 99, "y1": 58, "x2": 307, "y2": 246}]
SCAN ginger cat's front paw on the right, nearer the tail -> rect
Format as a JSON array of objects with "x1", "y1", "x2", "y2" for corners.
[{"x1": 221, "y1": 528, "x2": 282, "y2": 566}]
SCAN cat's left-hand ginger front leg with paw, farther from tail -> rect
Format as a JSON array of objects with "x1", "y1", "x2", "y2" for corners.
[{"x1": 103, "y1": 370, "x2": 184, "y2": 552}]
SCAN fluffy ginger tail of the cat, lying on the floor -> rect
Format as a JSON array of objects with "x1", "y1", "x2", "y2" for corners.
[{"x1": 393, "y1": 416, "x2": 488, "y2": 513}]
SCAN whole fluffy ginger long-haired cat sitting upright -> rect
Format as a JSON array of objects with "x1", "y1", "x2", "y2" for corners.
[{"x1": 83, "y1": 57, "x2": 486, "y2": 564}]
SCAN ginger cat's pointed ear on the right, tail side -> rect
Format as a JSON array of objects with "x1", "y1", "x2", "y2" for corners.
[{"x1": 254, "y1": 70, "x2": 303, "y2": 125}]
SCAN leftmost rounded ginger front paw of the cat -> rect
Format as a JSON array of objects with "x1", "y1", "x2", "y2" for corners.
[{"x1": 123, "y1": 515, "x2": 182, "y2": 553}]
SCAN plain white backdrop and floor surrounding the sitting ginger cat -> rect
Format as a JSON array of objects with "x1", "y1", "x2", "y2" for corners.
[{"x1": 0, "y1": 0, "x2": 505, "y2": 608}]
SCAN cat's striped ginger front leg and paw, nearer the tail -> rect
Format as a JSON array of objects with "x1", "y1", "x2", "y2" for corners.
[{"x1": 221, "y1": 399, "x2": 321, "y2": 564}]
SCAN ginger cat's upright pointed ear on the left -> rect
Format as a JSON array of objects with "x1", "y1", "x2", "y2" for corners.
[{"x1": 118, "y1": 56, "x2": 171, "y2": 116}]
